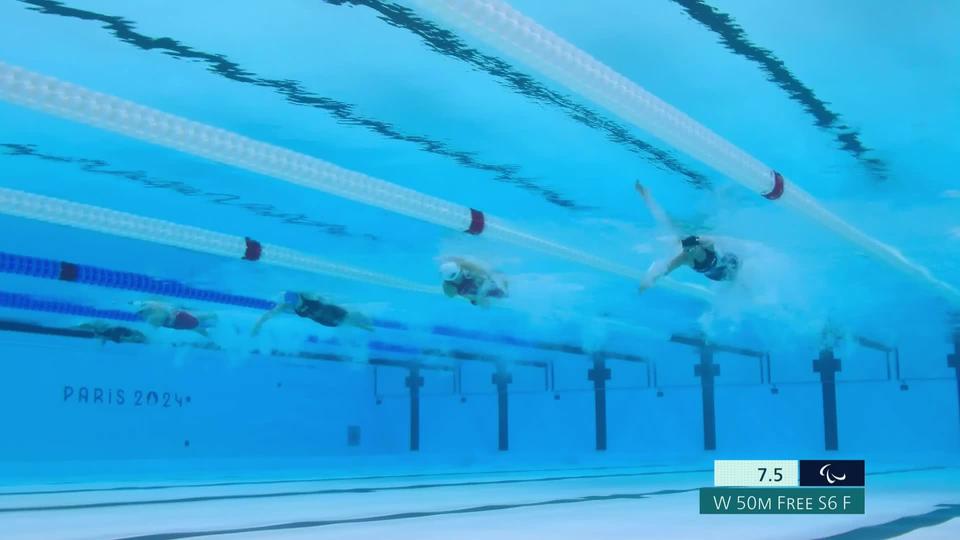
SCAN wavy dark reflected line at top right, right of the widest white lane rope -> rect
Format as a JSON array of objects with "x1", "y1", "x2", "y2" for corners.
[{"x1": 672, "y1": 0, "x2": 887, "y2": 180}]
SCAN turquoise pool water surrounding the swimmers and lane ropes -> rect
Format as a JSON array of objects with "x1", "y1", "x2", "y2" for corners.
[{"x1": 0, "y1": 0, "x2": 960, "y2": 538}]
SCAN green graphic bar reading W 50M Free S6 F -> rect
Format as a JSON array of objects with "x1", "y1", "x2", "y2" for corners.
[{"x1": 700, "y1": 487, "x2": 864, "y2": 514}]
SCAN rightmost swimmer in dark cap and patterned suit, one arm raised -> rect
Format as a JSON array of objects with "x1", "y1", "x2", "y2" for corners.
[{"x1": 634, "y1": 182, "x2": 740, "y2": 292}]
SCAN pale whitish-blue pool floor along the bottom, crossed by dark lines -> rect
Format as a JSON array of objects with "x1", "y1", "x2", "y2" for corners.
[{"x1": 0, "y1": 463, "x2": 960, "y2": 540}]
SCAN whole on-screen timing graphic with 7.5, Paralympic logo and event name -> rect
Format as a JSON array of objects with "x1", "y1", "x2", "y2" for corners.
[{"x1": 700, "y1": 459, "x2": 865, "y2": 514}]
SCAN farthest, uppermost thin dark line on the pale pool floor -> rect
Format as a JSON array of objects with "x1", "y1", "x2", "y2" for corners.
[{"x1": 0, "y1": 465, "x2": 663, "y2": 497}]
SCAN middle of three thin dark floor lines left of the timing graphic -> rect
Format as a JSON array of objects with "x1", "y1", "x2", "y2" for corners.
[{"x1": 0, "y1": 469, "x2": 712, "y2": 513}]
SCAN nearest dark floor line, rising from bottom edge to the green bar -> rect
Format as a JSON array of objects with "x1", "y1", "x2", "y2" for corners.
[{"x1": 114, "y1": 488, "x2": 700, "y2": 540}]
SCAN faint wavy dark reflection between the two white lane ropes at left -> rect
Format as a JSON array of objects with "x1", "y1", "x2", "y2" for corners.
[{"x1": 0, "y1": 143, "x2": 379, "y2": 240}]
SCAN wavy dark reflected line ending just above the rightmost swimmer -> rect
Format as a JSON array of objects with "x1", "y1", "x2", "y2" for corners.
[{"x1": 324, "y1": 0, "x2": 711, "y2": 189}]
